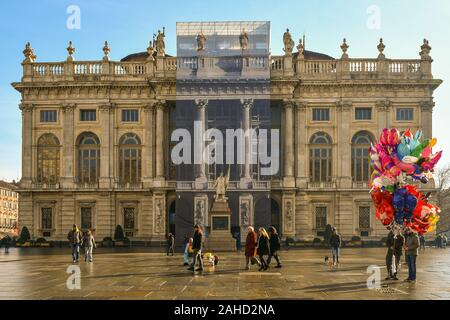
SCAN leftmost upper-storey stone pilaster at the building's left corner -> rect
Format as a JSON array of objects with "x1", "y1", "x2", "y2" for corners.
[{"x1": 20, "y1": 103, "x2": 33, "y2": 188}]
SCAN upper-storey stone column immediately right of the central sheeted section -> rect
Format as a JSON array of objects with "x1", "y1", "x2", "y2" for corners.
[{"x1": 283, "y1": 100, "x2": 295, "y2": 187}]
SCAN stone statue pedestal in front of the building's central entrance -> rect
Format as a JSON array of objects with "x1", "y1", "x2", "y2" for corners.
[{"x1": 204, "y1": 199, "x2": 236, "y2": 253}]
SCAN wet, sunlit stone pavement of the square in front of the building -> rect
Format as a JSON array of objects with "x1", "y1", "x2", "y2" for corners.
[{"x1": 0, "y1": 248, "x2": 450, "y2": 300}]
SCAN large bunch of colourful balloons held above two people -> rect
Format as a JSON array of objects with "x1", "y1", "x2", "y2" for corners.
[{"x1": 369, "y1": 128, "x2": 442, "y2": 234}]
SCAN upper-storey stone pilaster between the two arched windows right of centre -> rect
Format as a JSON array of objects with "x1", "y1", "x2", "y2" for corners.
[{"x1": 333, "y1": 101, "x2": 352, "y2": 188}]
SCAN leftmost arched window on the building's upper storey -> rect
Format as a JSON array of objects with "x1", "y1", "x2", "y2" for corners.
[{"x1": 37, "y1": 133, "x2": 60, "y2": 183}]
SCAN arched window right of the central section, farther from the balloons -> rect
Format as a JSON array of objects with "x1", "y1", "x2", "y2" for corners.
[{"x1": 309, "y1": 132, "x2": 332, "y2": 182}]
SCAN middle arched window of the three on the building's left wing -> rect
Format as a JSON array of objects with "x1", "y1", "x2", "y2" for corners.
[{"x1": 78, "y1": 132, "x2": 100, "y2": 183}]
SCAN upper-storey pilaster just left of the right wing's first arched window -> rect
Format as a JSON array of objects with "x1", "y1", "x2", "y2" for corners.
[{"x1": 295, "y1": 102, "x2": 309, "y2": 188}]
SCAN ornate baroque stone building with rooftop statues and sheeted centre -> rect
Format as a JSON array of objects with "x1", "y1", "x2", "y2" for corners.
[{"x1": 13, "y1": 22, "x2": 442, "y2": 242}]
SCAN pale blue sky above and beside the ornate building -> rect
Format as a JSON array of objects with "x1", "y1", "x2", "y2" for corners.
[{"x1": 0, "y1": 0, "x2": 450, "y2": 180}]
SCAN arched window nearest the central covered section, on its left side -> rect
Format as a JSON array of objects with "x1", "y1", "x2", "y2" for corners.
[{"x1": 119, "y1": 133, "x2": 142, "y2": 183}]
